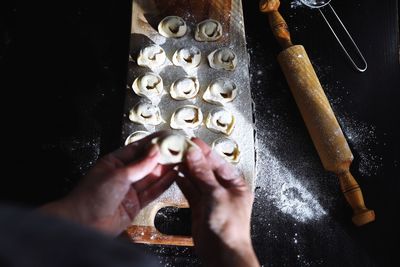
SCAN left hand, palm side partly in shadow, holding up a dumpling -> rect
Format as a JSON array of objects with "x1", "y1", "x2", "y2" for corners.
[{"x1": 41, "y1": 132, "x2": 177, "y2": 235}]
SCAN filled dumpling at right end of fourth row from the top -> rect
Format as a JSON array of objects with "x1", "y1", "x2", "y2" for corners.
[{"x1": 206, "y1": 107, "x2": 235, "y2": 135}]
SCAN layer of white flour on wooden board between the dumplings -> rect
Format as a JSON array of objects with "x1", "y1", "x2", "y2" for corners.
[{"x1": 122, "y1": 4, "x2": 255, "y2": 208}]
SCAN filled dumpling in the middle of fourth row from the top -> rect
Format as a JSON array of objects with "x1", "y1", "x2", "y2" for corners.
[{"x1": 170, "y1": 105, "x2": 203, "y2": 130}]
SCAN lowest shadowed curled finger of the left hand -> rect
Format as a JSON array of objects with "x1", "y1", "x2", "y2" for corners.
[{"x1": 138, "y1": 170, "x2": 178, "y2": 208}]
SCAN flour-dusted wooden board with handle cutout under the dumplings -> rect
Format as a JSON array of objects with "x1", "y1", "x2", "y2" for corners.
[{"x1": 122, "y1": 0, "x2": 255, "y2": 246}]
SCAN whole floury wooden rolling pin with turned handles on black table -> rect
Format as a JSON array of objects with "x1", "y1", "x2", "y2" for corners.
[{"x1": 260, "y1": 0, "x2": 375, "y2": 226}]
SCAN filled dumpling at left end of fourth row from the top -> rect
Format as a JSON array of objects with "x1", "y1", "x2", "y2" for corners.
[{"x1": 129, "y1": 102, "x2": 163, "y2": 125}]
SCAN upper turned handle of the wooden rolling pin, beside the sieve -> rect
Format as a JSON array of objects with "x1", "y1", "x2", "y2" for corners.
[{"x1": 260, "y1": 0, "x2": 293, "y2": 49}]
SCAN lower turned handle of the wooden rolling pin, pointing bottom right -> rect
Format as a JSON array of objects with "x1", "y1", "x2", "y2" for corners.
[{"x1": 339, "y1": 171, "x2": 375, "y2": 226}]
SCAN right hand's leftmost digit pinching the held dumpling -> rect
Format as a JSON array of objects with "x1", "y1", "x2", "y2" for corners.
[{"x1": 184, "y1": 147, "x2": 219, "y2": 193}]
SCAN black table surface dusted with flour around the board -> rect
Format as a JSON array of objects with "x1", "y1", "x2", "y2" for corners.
[{"x1": 0, "y1": 0, "x2": 400, "y2": 266}]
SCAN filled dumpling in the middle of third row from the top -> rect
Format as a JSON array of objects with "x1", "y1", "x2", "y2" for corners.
[{"x1": 169, "y1": 77, "x2": 200, "y2": 100}]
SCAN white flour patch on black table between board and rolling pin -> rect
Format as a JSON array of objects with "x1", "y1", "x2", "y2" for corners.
[{"x1": 248, "y1": 40, "x2": 327, "y2": 223}]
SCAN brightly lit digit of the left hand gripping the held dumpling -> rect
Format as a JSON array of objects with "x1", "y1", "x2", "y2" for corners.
[{"x1": 125, "y1": 145, "x2": 160, "y2": 183}]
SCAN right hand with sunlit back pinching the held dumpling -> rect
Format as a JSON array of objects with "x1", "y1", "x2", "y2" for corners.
[{"x1": 176, "y1": 138, "x2": 259, "y2": 267}]
